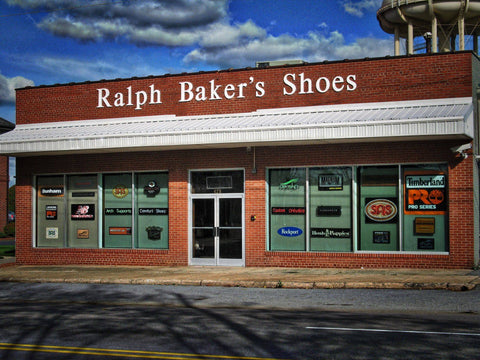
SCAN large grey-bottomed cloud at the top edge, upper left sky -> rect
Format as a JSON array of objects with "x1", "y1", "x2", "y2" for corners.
[{"x1": 14, "y1": 0, "x2": 231, "y2": 46}]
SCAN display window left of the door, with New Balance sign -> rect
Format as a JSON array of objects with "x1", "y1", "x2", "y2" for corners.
[{"x1": 36, "y1": 172, "x2": 168, "y2": 249}]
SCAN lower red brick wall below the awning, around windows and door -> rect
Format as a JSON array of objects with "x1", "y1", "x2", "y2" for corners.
[{"x1": 16, "y1": 141, "x2": 474, "y2": 268}]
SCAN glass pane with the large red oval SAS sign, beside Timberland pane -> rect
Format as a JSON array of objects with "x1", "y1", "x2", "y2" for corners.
[{"x1": 358, "y1": 166, "x2": 399, "y2": 251}]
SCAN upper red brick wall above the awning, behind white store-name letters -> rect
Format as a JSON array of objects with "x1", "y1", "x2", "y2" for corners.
[{"x1": 17, "y1": 52, "x2": 473, "y2": 124}]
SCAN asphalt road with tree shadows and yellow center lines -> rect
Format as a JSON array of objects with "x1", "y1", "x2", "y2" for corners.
[{"x1": 0, "y1": 283, "x2": 480, "y2": 360}]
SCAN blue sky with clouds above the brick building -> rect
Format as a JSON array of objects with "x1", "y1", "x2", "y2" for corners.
[{"x1": 0, "y1": 0, "x2": 393, "y2": 184}]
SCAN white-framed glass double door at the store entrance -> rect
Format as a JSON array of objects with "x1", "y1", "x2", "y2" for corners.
[{"x1": 191, "y1": 194, "x2": 244, "y2": 266}]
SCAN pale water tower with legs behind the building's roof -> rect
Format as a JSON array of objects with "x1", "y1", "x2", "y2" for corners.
[{"x1": 377, "y1": 0, "x2": 480, "y2": 55}]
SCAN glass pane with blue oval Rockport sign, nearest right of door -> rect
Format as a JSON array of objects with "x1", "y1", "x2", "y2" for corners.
[{"x1": 269, "y1": 168, "x2": 306, "y2": 250}]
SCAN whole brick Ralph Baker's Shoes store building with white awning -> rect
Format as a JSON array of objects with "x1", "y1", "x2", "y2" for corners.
[{"x1": 0, "y1": 52, "x2": 480, "y2": 268}]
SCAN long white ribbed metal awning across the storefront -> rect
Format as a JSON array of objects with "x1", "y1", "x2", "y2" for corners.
[{"x1": 0, "y1": 98, "x2": 474, "y2": 156}]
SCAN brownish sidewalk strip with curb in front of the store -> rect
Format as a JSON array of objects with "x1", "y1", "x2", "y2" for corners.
[{"x1": 0, "y1": 258, "x2": 480, "y2": 291}]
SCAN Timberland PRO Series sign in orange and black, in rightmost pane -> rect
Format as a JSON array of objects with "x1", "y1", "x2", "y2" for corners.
[{"x1": 405, "y1": 174, "x2": 447, "y2": 215}]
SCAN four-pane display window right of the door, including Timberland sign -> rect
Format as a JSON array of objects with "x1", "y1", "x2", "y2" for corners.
[{"x1": 268, "y1": 164, "x2": 448, "y2": 252}]
